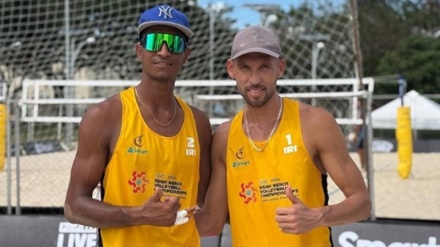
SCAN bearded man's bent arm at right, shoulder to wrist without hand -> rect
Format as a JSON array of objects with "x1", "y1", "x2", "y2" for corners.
[{"x1": 313, "y1": 106, "x2": 371, "y2": 226}]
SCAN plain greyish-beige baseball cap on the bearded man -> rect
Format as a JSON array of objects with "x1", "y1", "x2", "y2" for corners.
[{"x1": 230, "y1": 26, "x2": 281, "y2": 60}]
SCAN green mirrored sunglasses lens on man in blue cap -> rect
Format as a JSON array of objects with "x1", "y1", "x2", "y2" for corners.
[{"x1": 145, "y1": 33, "x2": 185, "y2": 54}]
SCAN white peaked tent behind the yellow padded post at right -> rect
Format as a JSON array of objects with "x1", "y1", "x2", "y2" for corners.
[{"x1": 371, "y1": 90, "x2": 440, "y2": 130}]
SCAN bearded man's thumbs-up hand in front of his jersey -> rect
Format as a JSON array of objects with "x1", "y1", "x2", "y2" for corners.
[{"x1": 275, "y1": 185, "x2": 318, "y2": 234}]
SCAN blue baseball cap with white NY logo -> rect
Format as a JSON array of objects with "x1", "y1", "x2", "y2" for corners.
[{"x1": 137, "y1": 4, "x2": 193, "y2": 38}]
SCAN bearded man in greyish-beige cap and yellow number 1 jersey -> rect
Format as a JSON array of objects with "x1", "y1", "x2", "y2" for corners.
[{"x1": 196, "y1": 26, "x2": 371, "y2": 247}]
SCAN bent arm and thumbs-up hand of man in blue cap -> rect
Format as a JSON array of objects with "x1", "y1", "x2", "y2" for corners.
[{"x1": 64, "y1": 97, "x2": 180, "y2": 228}]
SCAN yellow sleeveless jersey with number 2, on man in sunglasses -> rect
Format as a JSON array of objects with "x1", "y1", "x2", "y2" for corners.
[{"x1": 99, "y1": 87, "x2": 200, "y2": 247}]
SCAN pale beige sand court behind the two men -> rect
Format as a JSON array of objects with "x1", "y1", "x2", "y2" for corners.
[{"x1": 0, "y1": 151, "x2": 440, "y2": 220}]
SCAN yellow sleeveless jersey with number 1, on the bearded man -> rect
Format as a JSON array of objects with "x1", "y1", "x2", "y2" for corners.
[{"x1": 226, "y1": 99, "x2": 332, "y2": 247}]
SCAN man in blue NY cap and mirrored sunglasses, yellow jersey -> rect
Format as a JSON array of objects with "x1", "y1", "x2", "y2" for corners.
[{"x1": 64, "y1": 5, "x2": 212, "y2": 247}]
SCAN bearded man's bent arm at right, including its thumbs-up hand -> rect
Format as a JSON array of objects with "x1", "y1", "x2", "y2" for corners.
[{"x1": 276, "y1": 106, "x2": 371, "y2": 234}]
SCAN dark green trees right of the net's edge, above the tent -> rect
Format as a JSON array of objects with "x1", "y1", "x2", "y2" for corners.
[{"x1": 358, "y1": 0, "x2": 440, "y2": 94}]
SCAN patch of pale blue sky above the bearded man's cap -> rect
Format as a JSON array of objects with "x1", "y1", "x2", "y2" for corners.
[{"x1": 197, "y1": 0, "x2": 292, "y2": 27}]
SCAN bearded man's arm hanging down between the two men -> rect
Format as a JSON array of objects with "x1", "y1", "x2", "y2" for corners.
[{"x1": 195, "y1": 122, "x2": 230, "y2": 236}]
